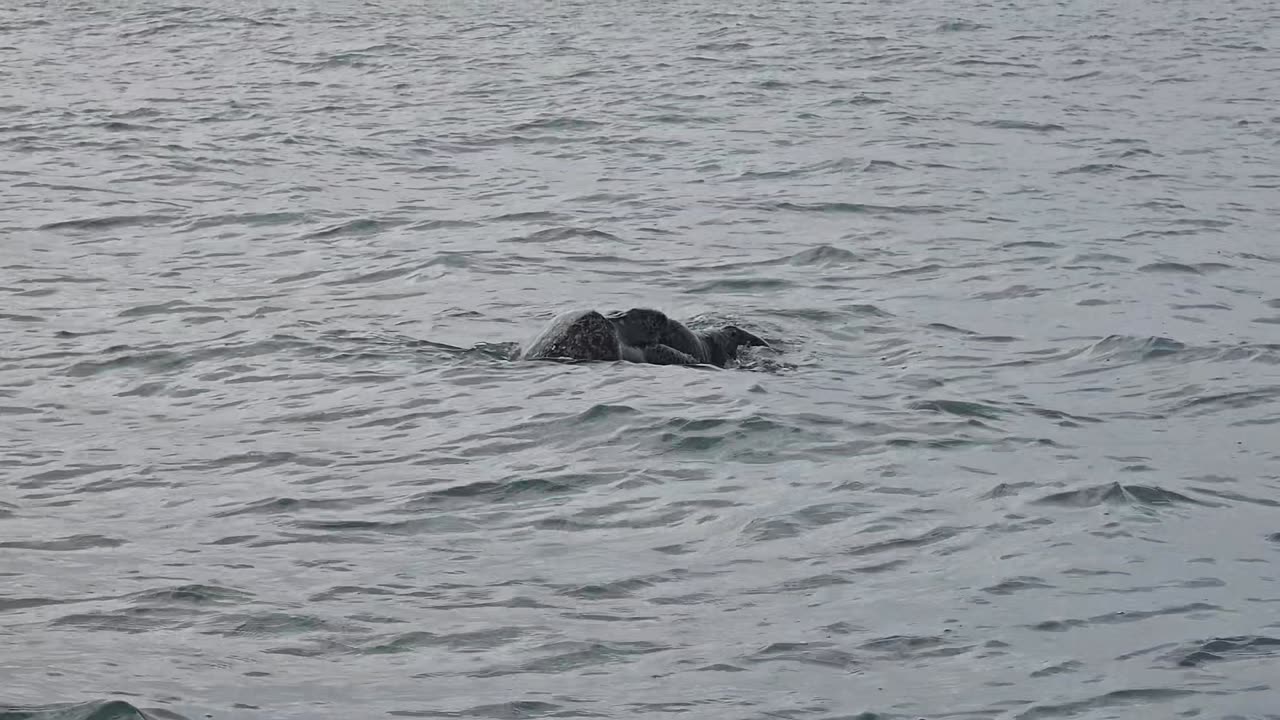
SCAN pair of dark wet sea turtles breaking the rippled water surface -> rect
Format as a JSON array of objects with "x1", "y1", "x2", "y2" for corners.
[{"x1": 521, "y1": 307, "x2": 769, "y2": 368}]
